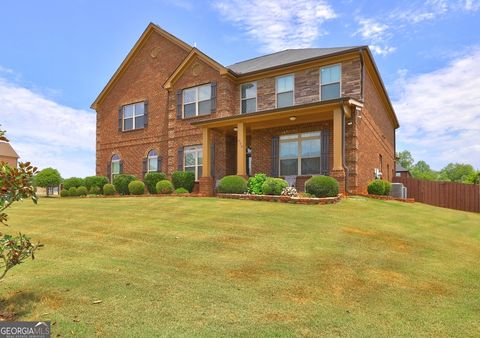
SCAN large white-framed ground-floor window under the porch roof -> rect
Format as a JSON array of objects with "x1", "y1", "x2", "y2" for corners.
[{"x1": 279, "y1": 131, "x2": 321, "y2": 176}]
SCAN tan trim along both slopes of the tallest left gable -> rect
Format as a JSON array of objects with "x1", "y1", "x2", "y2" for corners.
[{"x1": 90, "y1": 23, "x2": 193, "y2": 109}]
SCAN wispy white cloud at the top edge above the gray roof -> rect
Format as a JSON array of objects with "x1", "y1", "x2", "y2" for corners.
[{"x1": 214, "y1": 0, "x2": 336, "y2": 52}]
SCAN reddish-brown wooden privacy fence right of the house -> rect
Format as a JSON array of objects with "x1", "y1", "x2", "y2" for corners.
[{"x1": 393, "y1": 177, "x2": 480, "y2": 212}]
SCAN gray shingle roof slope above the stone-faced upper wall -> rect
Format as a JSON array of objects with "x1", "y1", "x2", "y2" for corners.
[{"x1": 227, "y1": 46, "x2": 363, "y2": 74}]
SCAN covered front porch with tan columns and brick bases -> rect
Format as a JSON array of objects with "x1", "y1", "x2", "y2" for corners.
[{"x1": 192, "y1": 99, "x2": 361, "y2": 196}]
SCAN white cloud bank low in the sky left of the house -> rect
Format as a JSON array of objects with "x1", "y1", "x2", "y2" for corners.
[{"x1": 0, "y1": 77, "x2": 95, "y2": 177}]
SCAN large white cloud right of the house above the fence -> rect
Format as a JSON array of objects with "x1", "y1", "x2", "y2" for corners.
[{"x1": 393, "y1": 49, "x2": 480, "y2": 169}]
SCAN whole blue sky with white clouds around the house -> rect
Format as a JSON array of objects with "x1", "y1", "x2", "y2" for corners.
[{"x1": 0, "y1": 0, "x2": 480, "y2": 178}]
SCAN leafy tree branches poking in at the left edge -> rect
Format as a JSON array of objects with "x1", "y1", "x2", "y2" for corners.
[{"x1": 0, "y1": 130, "x2": 41, "y2": 279}]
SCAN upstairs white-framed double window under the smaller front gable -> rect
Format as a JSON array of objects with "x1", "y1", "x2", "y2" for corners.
[{"x1": 182, "y1": 83, "x2": 212, "y2": 118}]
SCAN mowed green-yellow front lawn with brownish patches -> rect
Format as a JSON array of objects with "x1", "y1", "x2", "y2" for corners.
[{"x1": 0, "y1": 197, "x2": 480, "y2": 337}]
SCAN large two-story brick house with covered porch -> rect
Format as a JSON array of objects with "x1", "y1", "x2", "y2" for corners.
[{"x1": 92, "y1": 24, "x2": 399, "y2": 195}]
